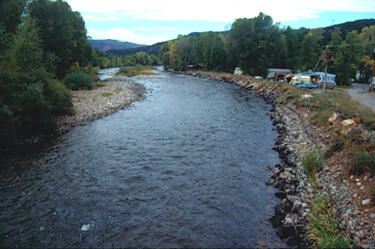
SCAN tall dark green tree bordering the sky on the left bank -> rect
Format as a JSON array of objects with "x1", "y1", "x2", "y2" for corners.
[{"x1": 29, "y1": 0, "x2": 91, "y2": 77}]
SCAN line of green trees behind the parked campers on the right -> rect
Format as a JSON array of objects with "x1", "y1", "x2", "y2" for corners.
[{"x1": 159, "y1": 13, "x2": 375, "y2": 84}]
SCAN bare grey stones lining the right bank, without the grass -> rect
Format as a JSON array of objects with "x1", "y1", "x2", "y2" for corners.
[{"x1": 182, "y1": 72, "x2": 375, "y2": 248}]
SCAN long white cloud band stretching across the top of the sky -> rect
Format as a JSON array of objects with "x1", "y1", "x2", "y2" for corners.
[{"x1": 67, "y1": 0, "x2": 375, "y2": 22}]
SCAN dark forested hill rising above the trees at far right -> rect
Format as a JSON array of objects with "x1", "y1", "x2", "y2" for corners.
[{"x1": 323, "y1": 19, "x2": 375, "y2": 43}]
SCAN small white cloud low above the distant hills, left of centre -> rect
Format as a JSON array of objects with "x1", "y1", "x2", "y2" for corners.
[{"x1": 87, "y1": 28, "x2": 167, "y2": 45}]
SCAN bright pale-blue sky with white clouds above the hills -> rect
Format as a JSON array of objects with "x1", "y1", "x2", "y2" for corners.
[{"x1": 66, "y1": 0, "x2": 375, "y2": 45}]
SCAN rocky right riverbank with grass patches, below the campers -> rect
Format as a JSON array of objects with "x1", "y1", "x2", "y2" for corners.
[{"x1": 183, "y1": 72, "x2": 375, "y2": 248}]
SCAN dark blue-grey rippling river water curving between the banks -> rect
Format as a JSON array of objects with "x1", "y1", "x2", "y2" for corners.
[{"x1": 0, "y1": 69, "x2": 286, "y2": 247}]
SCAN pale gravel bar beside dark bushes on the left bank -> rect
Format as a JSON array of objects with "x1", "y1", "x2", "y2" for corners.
[{"x1": 57, "y1": 79, "x2": 145, "y2": 134}]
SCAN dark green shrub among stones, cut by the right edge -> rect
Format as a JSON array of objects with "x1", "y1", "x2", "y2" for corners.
[{"x1": 349, "y1": 144, "x2": 375, "y2": 175}]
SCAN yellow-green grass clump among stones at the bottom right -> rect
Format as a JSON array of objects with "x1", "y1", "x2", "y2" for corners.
[{"x1": 308, "y1": 196, "x2": 350, "y2": 248}]
